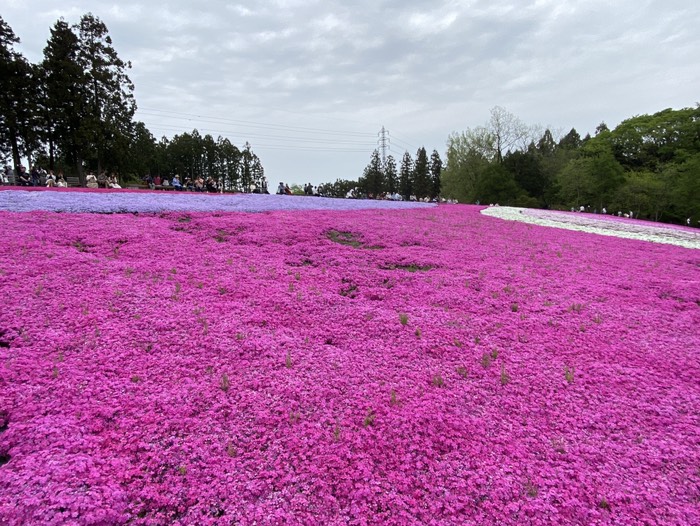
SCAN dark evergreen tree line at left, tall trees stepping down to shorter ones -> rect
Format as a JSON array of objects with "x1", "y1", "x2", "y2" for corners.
[{"x1": 0, "y1": 13, "x2": 267, "y2": 191}]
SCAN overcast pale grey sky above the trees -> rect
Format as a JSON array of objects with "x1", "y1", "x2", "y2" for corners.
[{"x1": 0, "y1": 0, "x2": 700, "y2": 188}]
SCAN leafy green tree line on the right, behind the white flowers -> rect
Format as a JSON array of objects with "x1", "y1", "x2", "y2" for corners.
[{"x1": 442, "y1": 105, "x2": 700, "y2": 224}]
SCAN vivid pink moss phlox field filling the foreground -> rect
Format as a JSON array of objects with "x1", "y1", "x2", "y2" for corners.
[{"x1": 0, "y1": 203, "x2": 700, "y2": 525}]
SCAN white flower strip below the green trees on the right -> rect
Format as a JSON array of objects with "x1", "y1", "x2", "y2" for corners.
[{"x1": 481, "y1": 206, "x2": 700, "y2": 249}]
